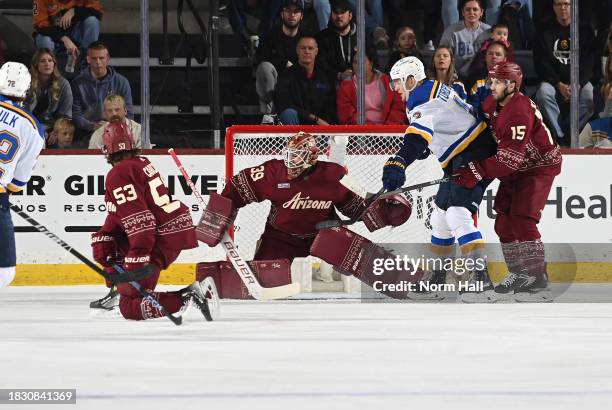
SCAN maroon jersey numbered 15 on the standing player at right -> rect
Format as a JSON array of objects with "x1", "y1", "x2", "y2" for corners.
[{"x1": 479, "y1": 93, "x2": 561, "y2": 178}]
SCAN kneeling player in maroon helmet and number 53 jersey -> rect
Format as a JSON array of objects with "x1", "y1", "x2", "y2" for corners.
[{"x1": 91, "y1": 122, "x2": 218, "y2": 320}]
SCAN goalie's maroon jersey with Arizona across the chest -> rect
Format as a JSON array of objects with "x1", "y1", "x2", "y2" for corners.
[{"x1": 221, "y1": 159, "x2": 364, "y2": 238}]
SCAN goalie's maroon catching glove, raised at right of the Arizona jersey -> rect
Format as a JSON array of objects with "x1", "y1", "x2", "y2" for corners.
[{"x1": 362, "y1": 195, "x2": 412, "y2": 232}]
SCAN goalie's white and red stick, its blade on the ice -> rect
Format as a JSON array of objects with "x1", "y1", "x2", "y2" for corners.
[{"x1": 168, "y1": 148, "x2": 300, "y2": 300}]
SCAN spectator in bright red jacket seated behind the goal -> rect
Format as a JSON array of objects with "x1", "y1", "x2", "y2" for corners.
[{"x1": 336, "y1": 47, "x2": 406, "y2": 124}]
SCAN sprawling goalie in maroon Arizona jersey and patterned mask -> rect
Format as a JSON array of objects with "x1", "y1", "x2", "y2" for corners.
[{"x1": 196, "y1": 132, "x2": 420, "y2": 298}]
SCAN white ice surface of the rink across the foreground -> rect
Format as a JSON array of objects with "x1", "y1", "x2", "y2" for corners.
[{"x1": 0, "y1": 284, "x2": 612, "y2": 410}]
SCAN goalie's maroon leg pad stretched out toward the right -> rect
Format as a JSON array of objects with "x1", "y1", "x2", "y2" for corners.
[{"x1": 310, "y1": 228, "x2": 423, "y2": 299}]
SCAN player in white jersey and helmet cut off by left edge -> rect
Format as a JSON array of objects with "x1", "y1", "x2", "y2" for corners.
[{"x1": 0, "y1": 61, "x2": 45, "y2": 287}]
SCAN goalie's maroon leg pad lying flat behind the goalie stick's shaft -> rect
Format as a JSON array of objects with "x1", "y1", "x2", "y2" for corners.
[{"x1": 196, "y1": 259, "x2": 291, "y2": 299}]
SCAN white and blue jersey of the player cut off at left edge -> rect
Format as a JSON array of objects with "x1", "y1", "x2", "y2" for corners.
[{"x1": 0, "y1": 96, "x2": 45, "y2": 193}]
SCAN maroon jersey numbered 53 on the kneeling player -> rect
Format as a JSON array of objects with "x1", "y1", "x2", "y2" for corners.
[{"x1": 101, "y1": 157, "x2": 198, "y2": 269}]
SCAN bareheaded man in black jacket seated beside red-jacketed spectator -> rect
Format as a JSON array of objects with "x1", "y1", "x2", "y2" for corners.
[{"x1": 275, "y1": 36, "x2": 336, "y2": 125}]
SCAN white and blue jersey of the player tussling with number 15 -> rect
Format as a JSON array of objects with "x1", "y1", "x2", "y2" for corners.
[{"x1": 405, "y1": 80, "x2": 487, "y2": 168}]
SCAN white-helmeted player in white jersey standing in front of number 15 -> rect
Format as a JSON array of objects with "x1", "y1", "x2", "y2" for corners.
[{"x1": 383, "y1": 57, "x2": 496, "y2": 302}]
